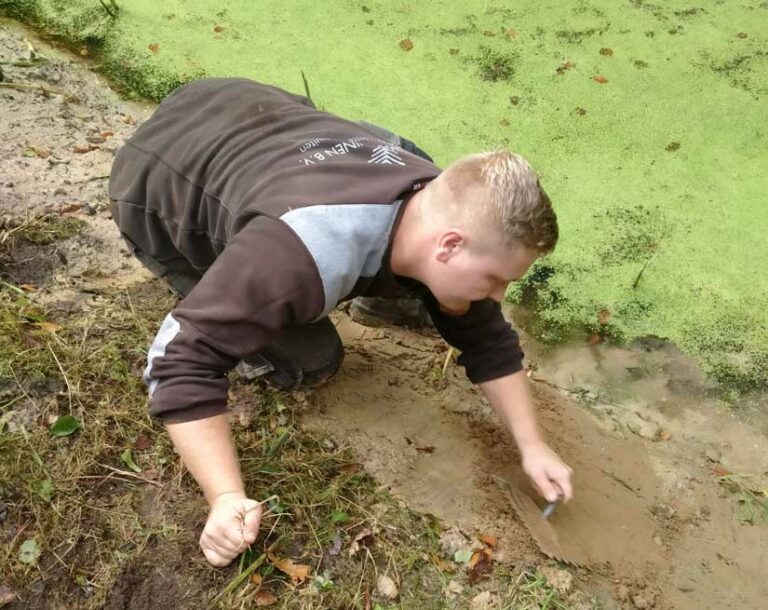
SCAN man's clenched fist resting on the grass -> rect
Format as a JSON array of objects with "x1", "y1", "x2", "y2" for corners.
[{"x1": 200, "y1": 492, "x2": 262, "y2": 568}]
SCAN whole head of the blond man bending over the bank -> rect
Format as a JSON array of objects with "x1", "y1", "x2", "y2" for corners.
[{"x1": 402, "y1": 150, "x2": 558, "y2": 312}]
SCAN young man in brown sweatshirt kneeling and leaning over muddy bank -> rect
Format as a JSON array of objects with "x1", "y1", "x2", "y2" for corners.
[{"x1": 109, "y1": 79, "x2": 572, "y2": 566}]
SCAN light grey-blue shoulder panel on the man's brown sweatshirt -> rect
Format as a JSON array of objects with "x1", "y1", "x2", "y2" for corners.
[{"x1": 280, "y1": 201, "x2": 402, "y2": 317}]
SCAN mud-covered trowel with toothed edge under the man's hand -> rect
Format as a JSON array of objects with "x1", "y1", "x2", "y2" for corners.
[{"x1": 492, "y1": 475, "x2": 587, "y2": 567}]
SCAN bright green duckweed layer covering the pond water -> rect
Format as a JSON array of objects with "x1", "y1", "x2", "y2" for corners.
[{"x1": 0, "y1": 0, "x2": 768, "y2": 389}]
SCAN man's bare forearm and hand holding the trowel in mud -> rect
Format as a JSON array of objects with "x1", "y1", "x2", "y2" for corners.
[{"x1": 479, "y1": 370, "x2": 573, "y2": 502}]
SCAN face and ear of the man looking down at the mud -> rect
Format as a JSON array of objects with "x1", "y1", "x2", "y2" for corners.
[{"x1": 427, "y1": 231, "x2": 539, "y2": 314}]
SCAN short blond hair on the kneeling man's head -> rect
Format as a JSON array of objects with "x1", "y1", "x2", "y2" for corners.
[{"x1": 426, "y1": 150, "x2": 558, "y2": 254}]
